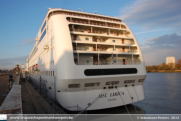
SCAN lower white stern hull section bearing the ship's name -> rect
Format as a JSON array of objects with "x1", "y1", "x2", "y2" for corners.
[{"x1": 58, "y1": 85, "x2": 145, "y2": 111}]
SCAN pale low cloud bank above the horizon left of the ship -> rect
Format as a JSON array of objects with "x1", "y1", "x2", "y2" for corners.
[{"x1": 0, "y1": 56, "x2": 28, "y2": 69}]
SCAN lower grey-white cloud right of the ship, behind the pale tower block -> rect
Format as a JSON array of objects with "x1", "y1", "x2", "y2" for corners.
[{"x1": 140, "y1": 33, "x2": 181, "y2": 65}]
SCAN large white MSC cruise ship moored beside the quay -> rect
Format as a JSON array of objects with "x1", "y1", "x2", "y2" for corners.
[{"x1": 26, "y1": 8, "x2": 146, "y2": 111}]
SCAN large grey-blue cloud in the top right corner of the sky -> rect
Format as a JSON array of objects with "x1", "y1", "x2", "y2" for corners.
[{"x1": 120, "y1": 0, "x2": 181, "y2": 29}]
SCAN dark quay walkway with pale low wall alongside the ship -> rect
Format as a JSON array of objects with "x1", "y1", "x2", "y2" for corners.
[{"x1": 0, "y1": 77, "x2": 66, "y2": 114}]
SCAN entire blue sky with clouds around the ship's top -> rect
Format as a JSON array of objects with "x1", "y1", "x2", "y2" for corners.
[{"x1": 0, "y1": 0, "x2": 181, "y2": 69}]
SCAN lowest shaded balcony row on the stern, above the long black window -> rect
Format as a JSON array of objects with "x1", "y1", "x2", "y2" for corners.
[{"x1": 74, "y1": 53, "x2": 141, "y2": 65}]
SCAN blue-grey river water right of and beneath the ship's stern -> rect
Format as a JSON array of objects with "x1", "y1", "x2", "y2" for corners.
[{"x1": 88, "y1": 73, "x2": 181, "y2": 114}]
